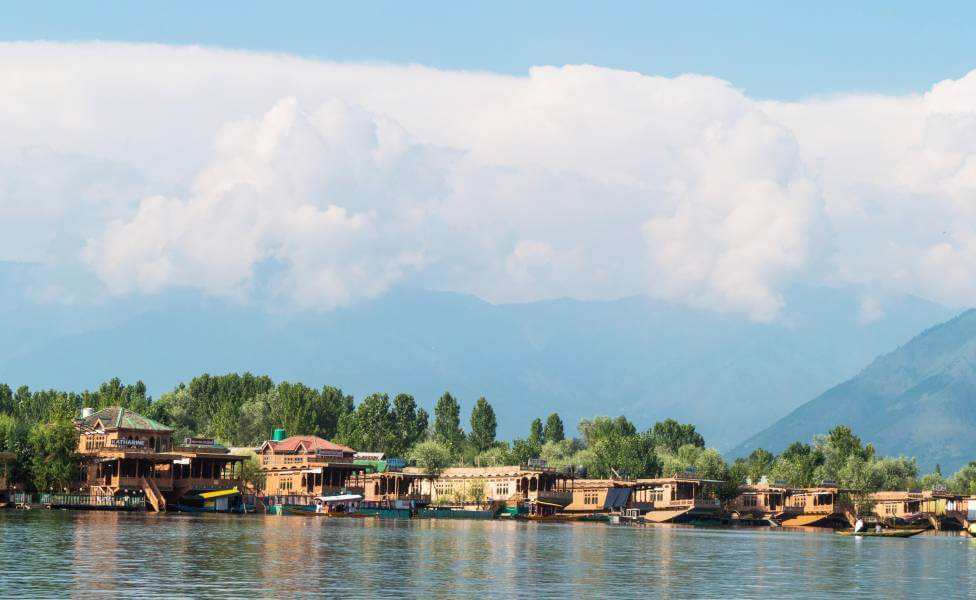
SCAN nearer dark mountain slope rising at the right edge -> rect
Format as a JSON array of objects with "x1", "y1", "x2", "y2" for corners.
[{"x1": 730, "y1": 310, "x2": 976, "y2": 473}]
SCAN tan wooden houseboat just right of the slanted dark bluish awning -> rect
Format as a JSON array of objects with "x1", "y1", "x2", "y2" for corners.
[{"x1": 631, "y1": 471, "x2": 723, "y2": 523}]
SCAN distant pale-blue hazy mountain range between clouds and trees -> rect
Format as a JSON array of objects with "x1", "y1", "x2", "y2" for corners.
[{"x1": 0, "y1": 270, "x2": 950, "y2": 448}]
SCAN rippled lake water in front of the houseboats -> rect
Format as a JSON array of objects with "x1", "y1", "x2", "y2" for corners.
[{"x1": 0, "y1": 510, "x2": 976, "y2": 599}]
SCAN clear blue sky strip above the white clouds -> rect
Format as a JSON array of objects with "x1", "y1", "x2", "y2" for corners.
[{"x1": 0, "y1": 0, "x2": 976, "y2": 99}]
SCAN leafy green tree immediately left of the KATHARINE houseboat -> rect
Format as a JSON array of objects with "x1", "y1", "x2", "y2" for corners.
[{"x1": 27, "y1": 422, "x2": 78, "y2": 491}]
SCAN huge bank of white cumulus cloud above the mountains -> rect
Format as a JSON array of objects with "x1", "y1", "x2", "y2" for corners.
[{"x1": 0, "y1": 43, "x2": 976, "y2": 320}]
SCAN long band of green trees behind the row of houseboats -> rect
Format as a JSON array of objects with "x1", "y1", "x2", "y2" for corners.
[{"x1": 0, "y1": 373, "x2": 976, "y2": 498}]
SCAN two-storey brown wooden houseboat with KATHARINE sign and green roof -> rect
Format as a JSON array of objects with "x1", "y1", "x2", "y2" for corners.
[{"x1": 75, "y1": 407, "x2": 244, "y2": 511}]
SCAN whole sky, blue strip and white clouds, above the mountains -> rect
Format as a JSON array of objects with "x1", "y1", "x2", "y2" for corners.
[{"x1": 0, "y1": 2, "x2": 976, "y2": 322}]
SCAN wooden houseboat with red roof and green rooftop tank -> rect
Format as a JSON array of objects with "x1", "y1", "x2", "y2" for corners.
[{"x1": 257, "y1": 429, "x2": 367, "y2": 506}]
